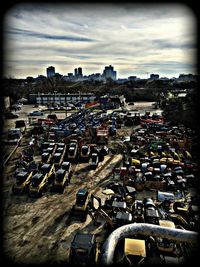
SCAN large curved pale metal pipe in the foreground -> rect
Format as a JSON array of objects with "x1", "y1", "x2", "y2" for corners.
[{"x1": 100, "y1": 223, "x2": 198, "y2": 265}]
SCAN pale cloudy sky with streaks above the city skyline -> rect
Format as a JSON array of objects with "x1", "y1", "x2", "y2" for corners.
[{"x1": 3, "y1": 2, "x2": 197, "y2": 78}]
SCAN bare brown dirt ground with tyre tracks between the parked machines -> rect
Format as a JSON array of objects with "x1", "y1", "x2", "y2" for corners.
[{"x1": 2, "y1": 102, "x2": 157, "y2": 264}]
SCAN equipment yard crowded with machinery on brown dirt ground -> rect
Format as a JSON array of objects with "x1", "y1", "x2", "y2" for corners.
[{"x1": 2, "y1": 99, "x2": 199, "y2": 265}]
